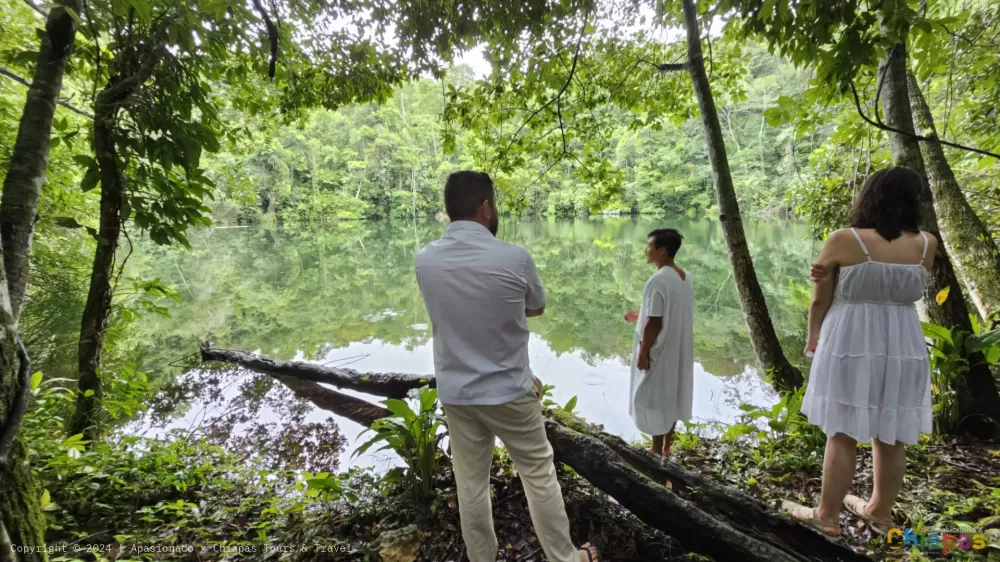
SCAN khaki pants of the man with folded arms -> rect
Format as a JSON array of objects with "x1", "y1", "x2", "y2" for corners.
[{"x1": 444, "y1": 392, "x2": 580, "y2": 562}]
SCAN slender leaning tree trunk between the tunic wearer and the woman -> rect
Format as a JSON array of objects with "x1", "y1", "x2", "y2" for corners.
[{"x1": 683, "y1": 0, "x2": 803, "y2": 390}]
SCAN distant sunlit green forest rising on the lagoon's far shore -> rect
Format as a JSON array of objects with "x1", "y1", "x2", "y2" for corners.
[{"x1": 209, "y1": 45, "x2": 832, "y2": 222}]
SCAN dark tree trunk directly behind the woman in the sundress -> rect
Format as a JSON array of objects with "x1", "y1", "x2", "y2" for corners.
[{"x1": 880, "y1": 45, "x2": 1000, "y2": 437}]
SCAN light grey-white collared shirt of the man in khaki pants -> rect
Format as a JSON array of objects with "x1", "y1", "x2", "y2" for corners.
[{"x1": 416, "y1": 221, "x2": 545, "y2": 406}]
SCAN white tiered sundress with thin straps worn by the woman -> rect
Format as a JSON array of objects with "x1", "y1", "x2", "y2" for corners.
[{"x1": 802, "y1": 228, "x2": 933, "y2": 445}]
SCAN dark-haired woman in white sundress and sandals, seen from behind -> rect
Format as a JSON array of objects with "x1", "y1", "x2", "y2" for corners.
[{"x1": 784, "y1": 167, "x2": 938, "y2": 536}]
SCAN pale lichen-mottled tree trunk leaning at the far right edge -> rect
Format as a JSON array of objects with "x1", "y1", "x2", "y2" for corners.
[{"x1": 907, "y1": 74, "x2": 1000, "y2": 319}]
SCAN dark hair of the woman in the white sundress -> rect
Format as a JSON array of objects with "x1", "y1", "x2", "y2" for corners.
[{"x1": 849, "y1": 166, "x2": 923, "y2": 241}]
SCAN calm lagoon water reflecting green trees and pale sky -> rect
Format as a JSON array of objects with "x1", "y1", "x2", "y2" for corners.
[{"x1": 130, "y1": 217, "x2": 819, "y2": 469}]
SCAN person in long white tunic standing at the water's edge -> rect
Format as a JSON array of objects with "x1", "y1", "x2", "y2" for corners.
[{"x1": 625, "y1": 228, "x2": 694, "y2": 457}]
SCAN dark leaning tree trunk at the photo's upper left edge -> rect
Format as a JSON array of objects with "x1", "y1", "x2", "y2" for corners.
[{"x1": 0, "y1": 0, "x2": 78, "y2": 322}]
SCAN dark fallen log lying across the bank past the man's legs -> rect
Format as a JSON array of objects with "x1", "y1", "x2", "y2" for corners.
[{"x1": 202, "y1": 345, "x2": 870, "y2": 562}]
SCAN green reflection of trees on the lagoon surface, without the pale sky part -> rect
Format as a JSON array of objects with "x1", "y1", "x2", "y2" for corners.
[{"x1": 132, "y1": 219, "x2": 813, "y2": 375}]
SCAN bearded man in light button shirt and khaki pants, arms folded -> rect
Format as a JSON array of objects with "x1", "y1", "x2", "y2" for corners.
[{"x1": 416, "y1": 171, "x2": 597, "y2": 562}]
